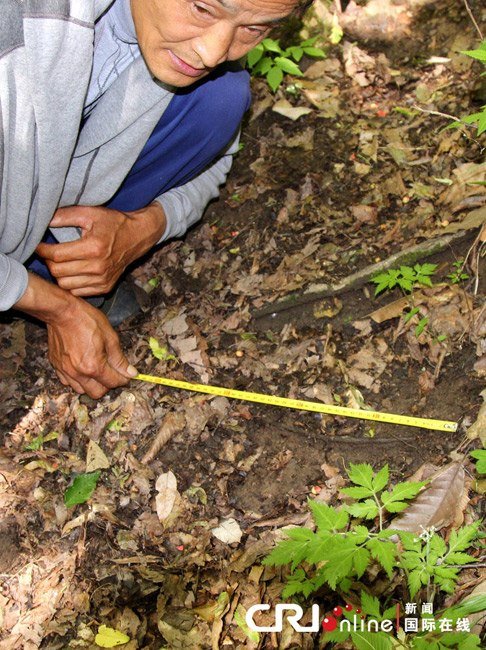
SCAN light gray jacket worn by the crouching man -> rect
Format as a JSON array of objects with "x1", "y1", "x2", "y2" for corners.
[{"x1": 0, "y1": 0, "x2": 236, "y2": 311}]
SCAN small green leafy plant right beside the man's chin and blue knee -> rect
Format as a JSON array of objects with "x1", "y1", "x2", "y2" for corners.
[{"x1": 247, "y1": 37, "x2": 326, "y2": 92}]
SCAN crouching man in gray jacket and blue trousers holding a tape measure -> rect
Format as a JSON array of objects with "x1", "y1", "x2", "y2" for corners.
[{"x1": 0, "y1": 0, "x2": 303, "y2": 398}]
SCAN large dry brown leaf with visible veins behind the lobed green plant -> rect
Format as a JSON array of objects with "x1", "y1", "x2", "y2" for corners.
[{"x1": 390, "y1": 463, "x2": 465, "y2": 534}]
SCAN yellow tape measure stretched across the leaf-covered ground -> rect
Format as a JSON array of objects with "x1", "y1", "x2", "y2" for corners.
[{"x1": 135, "y1": 375, "x2": 457, "y2": 431}]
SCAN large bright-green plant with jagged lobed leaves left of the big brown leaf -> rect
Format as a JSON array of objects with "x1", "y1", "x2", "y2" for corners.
[{"x1": 264, "y1": 464, "x2": 425, "y2": 598}]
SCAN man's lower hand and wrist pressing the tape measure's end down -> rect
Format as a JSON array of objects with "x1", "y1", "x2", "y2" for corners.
[{"x1": 15, "y1": 275, "x2": 137, "y2": 399}]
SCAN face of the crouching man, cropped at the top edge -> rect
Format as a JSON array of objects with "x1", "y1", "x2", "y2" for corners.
[{"x1": 131, "y1": 0, "x2": 298, "y2": 88}]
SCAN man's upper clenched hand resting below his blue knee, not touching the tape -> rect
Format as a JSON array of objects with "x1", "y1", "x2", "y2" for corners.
[{"x1": 37, "y1": 203, "x2": 166, "y2": 296}]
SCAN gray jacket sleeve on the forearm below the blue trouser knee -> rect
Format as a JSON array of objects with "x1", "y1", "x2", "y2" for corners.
[{"x1": 156, "y1": 133, "x2": 240, "y2": 243}]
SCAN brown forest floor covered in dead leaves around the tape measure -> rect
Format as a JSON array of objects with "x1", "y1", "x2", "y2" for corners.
[{"x1": 0, "y1": 1, "x2": 486, "y2": 650}]
